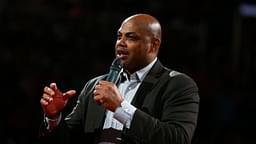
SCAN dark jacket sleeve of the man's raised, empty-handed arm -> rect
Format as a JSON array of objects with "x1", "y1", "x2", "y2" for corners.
[{"x1": 39, "y1": 77, "x2": 100, "y2": 144}]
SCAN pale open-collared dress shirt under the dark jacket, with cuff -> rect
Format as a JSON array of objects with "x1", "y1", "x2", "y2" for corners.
[{"x1": 103, "y1": 58, "x2": 157, "y2": 130}]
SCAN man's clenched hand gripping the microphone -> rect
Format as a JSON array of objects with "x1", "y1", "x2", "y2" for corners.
[{"x1": 93, "y1": 81, "x2": 124, "y2": 112}]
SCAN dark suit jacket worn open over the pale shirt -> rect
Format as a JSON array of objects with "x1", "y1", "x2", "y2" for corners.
[{"x1": 41, "y1": 60, "x2": 199, "y2": 144}]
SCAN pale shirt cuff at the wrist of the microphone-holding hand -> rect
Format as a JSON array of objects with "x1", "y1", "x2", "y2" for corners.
[{"x1": 114, "y1": 100, "x2": 137, "y2": 128}]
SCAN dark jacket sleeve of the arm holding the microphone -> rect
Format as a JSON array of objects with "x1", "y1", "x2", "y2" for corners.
[{"x1": 125, "y1": 74, "x2": 199, "y2": 144}]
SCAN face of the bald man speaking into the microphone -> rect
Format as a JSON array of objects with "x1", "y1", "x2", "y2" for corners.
[{"x1": 115, "y1": 20, "x2": 151, "y2": 73}]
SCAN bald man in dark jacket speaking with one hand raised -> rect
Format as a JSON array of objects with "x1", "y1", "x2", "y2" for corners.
[{"x1": 40, "y1": 14, "x2": 199, "y2": 144}]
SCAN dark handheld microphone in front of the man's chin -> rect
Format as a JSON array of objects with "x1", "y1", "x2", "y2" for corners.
[{"x1": 106, "y1": 57, "x2": 123, "y2": 84}]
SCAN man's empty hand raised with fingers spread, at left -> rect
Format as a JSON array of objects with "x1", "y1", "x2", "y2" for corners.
[{"x1": 40, "y1": 83, "x2": 76, "y2": 118}]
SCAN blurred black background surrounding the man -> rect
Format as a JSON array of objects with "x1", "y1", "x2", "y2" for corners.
[{"x1": 0, "y1": 0, "x2": 256, "y2": 144}]
